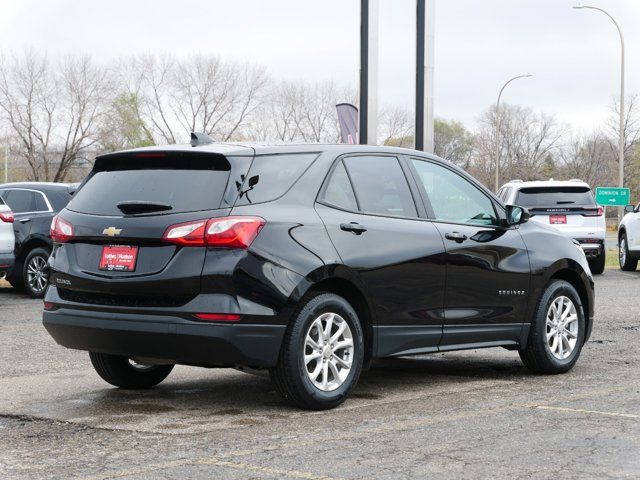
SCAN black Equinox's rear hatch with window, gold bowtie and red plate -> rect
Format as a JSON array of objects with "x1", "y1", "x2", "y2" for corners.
[{"x1": 52, "y1": 151, "x2": 251, "y2": 306}]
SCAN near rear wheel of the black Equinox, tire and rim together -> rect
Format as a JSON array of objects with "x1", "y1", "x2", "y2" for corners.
[{"x1": 270, "y1": 293, "x2": 364, "y2": 410}]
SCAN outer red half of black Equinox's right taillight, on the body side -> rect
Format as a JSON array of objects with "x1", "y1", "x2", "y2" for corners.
[{"x1": 206, "y1": 217, "x2": 265, "y2": 248}]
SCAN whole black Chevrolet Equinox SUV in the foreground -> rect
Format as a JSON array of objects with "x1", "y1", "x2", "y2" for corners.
[{"x1": 44, "y1": 141, "x2": 594, "y2": 409}]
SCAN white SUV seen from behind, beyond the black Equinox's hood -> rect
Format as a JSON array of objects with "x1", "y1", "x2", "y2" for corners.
[{"x1": 498, "y1": 180, "x2": 604, "y2": 274}]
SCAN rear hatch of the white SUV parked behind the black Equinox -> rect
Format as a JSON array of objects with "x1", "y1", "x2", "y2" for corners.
[{"x1": 515, "y1": 185, "x2": 605, "y2": 238}]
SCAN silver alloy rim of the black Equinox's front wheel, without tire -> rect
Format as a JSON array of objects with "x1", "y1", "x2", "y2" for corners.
[{"x1": 547, "y1": 296, "x2": 579, "y2": 360}]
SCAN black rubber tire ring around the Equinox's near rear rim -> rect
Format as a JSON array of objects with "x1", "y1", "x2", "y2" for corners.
[{"x1": 292, "y1": 294, "x2": 364, "y2": 405}]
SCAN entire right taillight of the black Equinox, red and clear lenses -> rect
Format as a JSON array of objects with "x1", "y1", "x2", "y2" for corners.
[{"x1": 162, "y1": 217, "x2": 265, "y2": 249}]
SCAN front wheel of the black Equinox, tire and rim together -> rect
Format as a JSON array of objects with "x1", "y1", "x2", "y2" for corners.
[{"x1": 519, "y1": 280, "x2": 586, "y2": 374}]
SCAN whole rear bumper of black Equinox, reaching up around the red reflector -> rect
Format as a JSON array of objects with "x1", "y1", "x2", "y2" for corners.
[{"x1": 43, "y1": 285, "x2": 286, "y2": 368}]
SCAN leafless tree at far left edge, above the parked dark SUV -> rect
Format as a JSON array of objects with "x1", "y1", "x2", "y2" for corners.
[{"x1": 0, "y1": 50, "x2": 106, "y2": 181}]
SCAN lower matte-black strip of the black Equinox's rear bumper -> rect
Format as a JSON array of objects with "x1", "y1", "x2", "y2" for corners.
[{"x1": 43, "y1": 308, "x2": 285, "y2": 367}]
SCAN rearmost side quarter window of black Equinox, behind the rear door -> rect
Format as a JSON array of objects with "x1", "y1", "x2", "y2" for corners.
[{"x1": 236, "y1": 153, "x2": 318, "y2": 205}]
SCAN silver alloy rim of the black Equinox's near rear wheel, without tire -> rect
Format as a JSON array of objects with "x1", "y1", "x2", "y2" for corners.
[{"x1": 303, "y1": 313, "x2": 354, "y2": 392}]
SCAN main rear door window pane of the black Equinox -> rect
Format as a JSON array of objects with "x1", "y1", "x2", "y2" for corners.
[{"x1": 344, "y1": 155, "x2": 418, "y2": 217}]
